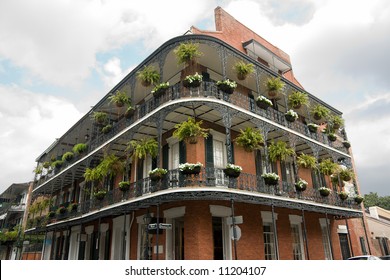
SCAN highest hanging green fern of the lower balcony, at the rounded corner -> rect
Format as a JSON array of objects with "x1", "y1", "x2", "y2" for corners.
[{"x1": 173, "y1": 117, "x2": 208, "y2": 144}]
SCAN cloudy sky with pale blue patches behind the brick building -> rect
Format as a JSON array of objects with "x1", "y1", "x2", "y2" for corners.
[{"x1": 0, "y1": 0, "x2": 390, "y2": 195}]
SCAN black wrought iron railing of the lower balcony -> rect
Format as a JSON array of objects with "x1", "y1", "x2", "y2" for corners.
[{"x1": 28, "y1": 168, "x2": 359, "y2": 230}]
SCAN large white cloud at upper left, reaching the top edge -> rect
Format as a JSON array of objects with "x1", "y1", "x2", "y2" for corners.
[{"x1": 0, "y1": 0, "x2": 214, "y2": 86}]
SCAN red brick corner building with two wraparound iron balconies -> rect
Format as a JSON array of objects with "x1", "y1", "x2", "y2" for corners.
[{"x1": 26, "y1": 7, "x2": 371, "y2": 260}]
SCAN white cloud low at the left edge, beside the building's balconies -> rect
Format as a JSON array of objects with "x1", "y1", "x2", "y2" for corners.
[{"x1": 0, "y1": 85, "x2": 82, "y2": 189}]
